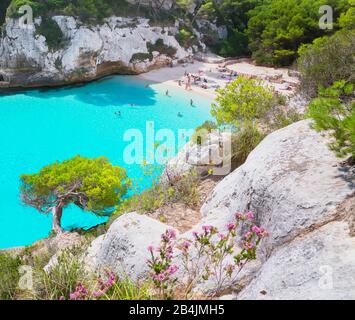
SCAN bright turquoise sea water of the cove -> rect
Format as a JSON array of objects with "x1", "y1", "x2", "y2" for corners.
[{"x1": 0, "y1": 76, "x2": 210, "y2": 248}]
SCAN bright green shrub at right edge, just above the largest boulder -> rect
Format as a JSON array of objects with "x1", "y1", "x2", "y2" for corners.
[{"x1": 308, "y1": 81, "x2": 355, "y2": 159}]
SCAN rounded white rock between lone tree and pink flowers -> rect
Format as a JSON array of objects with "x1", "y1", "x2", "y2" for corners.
[{"x1": 85, "y1": 212, "x2": 178, "y2": 280}]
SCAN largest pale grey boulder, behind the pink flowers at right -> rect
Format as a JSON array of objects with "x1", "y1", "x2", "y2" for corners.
[{"x1": 201, "y1": 120, "x2": 355, "y2": 260}]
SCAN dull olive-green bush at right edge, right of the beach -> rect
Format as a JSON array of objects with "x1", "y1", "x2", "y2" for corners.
[{"x1": 298, "y1": 30, "x2": 355, "y2": 97}]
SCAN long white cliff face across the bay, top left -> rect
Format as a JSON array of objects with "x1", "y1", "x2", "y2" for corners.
[{"x1": 0, "y1": 16, "x2": 197, "y2": 87}]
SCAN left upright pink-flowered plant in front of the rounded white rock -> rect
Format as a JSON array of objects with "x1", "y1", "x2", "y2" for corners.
[{"x1": 148, "y1": 229, "x2": 178, "y2": 299}]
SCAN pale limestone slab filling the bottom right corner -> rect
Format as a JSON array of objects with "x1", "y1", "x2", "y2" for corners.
[{"x1": 237, "y1": 222, "x2": 355, "y2": 300}]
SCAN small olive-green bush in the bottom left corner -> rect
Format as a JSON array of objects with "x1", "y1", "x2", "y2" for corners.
[{"x1": 0, "y1": 253, "x2": 21, "y2": 300}]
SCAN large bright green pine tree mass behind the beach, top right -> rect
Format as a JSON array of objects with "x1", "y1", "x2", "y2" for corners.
[{"x1": 247, "y1": 0, "x2": 350, "y2": 66}]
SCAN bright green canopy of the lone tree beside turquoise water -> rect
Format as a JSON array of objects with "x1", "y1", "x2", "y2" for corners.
[{"x1": 20, "y1": 156, "x2": 130, "y2": 229}]
